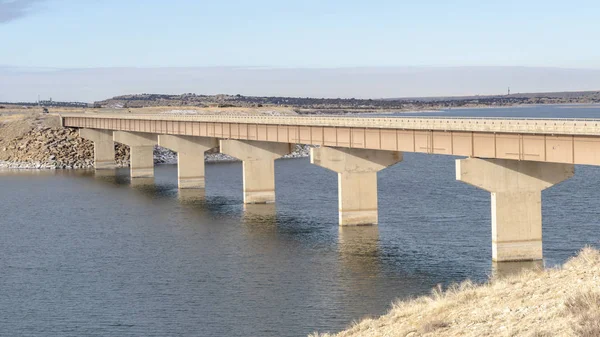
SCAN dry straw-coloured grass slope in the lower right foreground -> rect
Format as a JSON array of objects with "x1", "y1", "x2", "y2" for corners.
[{"x1": 312, "y1": 248, "x2": 600, "y2": 337}]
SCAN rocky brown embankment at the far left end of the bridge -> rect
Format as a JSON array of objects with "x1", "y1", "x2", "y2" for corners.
[{"x1": 0, "y1": 119, "x2": 310, "y2": 169}]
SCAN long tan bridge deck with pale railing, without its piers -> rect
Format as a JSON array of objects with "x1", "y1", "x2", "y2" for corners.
[{"x1": 62, "y1": 113, "x2": 600, "y2": 165}]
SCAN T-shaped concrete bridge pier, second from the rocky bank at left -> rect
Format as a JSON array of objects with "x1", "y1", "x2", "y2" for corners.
[{"x1": 113, "y1": 131, "x2": 158, "y2": 178}]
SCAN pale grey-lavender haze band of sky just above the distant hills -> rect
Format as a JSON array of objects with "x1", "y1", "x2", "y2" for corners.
[{"x1": 0, "y1": 66, "x2": 600, "y2": 102}]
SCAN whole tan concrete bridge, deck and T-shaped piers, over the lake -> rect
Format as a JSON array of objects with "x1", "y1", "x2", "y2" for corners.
[{"x1": 61, "y1": 114, "x2": 600, "y2": 262}]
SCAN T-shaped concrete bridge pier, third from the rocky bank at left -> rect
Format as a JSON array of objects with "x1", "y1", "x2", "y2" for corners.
[{"x1": 158, "y1": 135, "x2": 219, "y2": 188}]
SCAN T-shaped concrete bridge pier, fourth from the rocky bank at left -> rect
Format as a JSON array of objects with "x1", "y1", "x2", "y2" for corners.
[{"x1": 220, "y1": 140, "x2": 291, "y2": 204}]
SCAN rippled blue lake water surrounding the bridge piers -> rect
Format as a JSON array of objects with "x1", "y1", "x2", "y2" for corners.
[{"x1": 0, "y1": 104, "x2": 600, "y2": 336}]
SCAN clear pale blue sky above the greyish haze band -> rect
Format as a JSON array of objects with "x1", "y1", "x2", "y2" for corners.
[{"x1": 0, "y1": 0, "x2": 600, "y2": 99}]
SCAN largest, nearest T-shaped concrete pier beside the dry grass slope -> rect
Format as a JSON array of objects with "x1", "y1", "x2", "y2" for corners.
[{"x1": 456, "y1": 158, "x2": 574, "y2": 262}]
